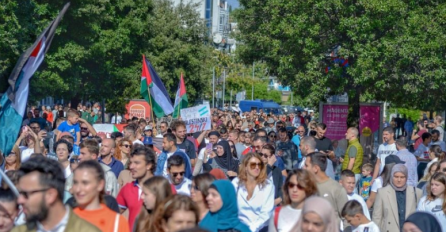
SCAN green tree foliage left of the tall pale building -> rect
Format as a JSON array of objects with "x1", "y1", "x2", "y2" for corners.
[{"x1": 0, "y1": 0, "x2": 212, "y2": 112}]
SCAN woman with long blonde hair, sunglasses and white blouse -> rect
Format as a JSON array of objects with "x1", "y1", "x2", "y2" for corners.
[{"x1": 232, "y1": 153, "x2": 274, "y2": 232}]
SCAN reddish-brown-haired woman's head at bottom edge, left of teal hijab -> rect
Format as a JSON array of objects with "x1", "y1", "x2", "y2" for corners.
[{"x1": 149, "y1": 195, "x2": 200, "y2": 232}]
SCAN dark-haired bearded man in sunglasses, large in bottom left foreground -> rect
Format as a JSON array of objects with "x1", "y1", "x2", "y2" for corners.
[{"x1": 12, "y1": 157, "x2": 100, "y2": 232}]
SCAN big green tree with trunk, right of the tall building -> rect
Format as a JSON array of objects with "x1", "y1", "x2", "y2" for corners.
[{"x1": 234, "y1": 0, "x2": 446, "y2": 126}]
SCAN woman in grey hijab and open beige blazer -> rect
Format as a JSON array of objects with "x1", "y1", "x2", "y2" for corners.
[{"x1": 372, "y1": 164, "x2": 422, "y2": 231}]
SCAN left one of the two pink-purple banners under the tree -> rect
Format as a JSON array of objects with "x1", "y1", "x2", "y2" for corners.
[{"x1": 322, "y1": 105, "x2": 348, "y2": 140}]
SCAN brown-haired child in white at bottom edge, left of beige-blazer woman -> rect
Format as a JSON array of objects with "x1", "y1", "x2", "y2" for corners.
[{"x1": 341, "y1": 200, "x2": 379, "y2": 232}]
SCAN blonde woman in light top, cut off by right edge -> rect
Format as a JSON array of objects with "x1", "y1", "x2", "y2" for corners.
[{"x1": 417, "y1": 172, "x2": 446, "y2": 228}]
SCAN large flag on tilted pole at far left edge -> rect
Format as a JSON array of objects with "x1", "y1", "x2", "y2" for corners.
[{"x1": 0, "y1": 3, "x2": 70, "y2": 156}]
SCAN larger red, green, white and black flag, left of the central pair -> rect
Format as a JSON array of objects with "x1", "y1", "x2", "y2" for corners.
[{"x1": 141, "y1": 55, "x2": 173, "y2": 118}]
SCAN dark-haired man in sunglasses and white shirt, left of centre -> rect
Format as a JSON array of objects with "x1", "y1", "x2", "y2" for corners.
[{"x1": 167, "y1": 152, "x2": 192, "y2": 196}]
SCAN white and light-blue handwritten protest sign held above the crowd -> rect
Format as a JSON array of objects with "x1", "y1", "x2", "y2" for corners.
[{"x1": 180, "y1": 104, "x2": 212, "y2": 133}]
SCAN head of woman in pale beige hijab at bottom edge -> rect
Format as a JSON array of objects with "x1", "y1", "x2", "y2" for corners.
[{"x1": 292, "y1": 196, "x2": 339, "y2": 232}]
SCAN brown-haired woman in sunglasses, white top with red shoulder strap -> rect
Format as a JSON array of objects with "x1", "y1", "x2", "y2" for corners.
[{"x1": 268, "y1": 169, "x2": 318, "y2": 232}]
